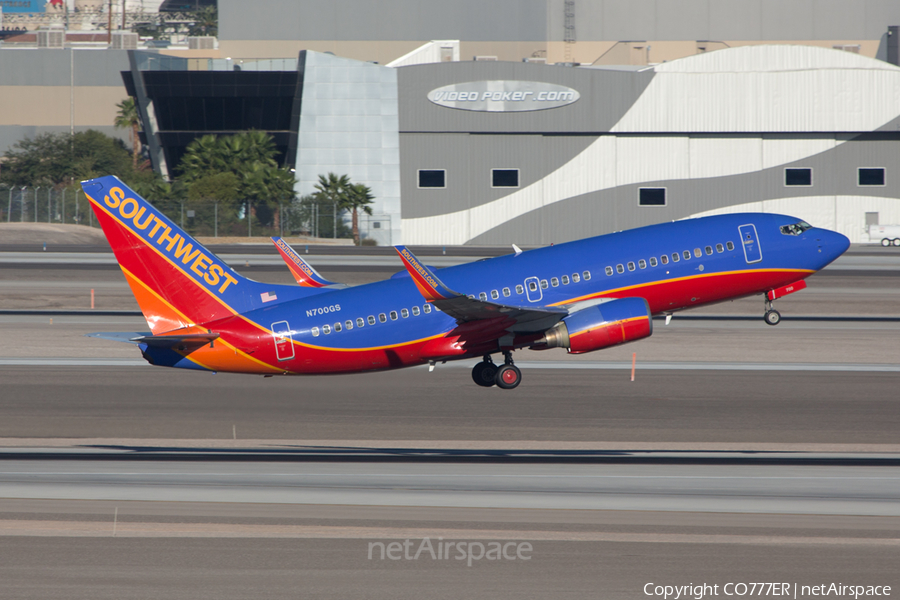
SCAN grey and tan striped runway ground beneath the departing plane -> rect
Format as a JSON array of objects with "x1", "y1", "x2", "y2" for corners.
[{"x1": 0, "y1": 248, "x2": 900, "y2": 600}]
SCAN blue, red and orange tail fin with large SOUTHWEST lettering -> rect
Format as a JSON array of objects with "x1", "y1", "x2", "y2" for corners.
[{"x1": 81, "y1": 176, "x2": 318, "y2": 334}]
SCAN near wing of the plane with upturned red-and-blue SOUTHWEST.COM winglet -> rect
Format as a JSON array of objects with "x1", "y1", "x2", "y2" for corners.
[{"x1": 394, "y1": 246, "x2": 569, "y2": 332}]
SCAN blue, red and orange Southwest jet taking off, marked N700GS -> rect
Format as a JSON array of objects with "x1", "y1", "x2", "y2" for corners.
[{"x1": 82, "y1": 176, "x2": 850, "y2": 389}]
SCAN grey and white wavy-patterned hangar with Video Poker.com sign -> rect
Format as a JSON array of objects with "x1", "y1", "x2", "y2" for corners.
[{"x1": 398, "y1": 45, "x2": 900, "y2": 244}]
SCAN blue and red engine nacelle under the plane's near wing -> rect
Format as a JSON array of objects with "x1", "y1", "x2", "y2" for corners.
[{"x1": 535, "y1": 298, "x2": 653, "y2": 354}]
